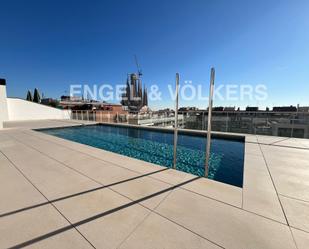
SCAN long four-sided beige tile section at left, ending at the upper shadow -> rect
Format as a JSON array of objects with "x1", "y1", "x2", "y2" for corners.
[{"x1": 2, "y1": 143, "x2": 100, "y2": 199}]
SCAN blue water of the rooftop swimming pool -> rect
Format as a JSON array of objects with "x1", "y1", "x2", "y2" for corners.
[{"x1": 40, "y1": 125, "x2": 244, "y2": 187}]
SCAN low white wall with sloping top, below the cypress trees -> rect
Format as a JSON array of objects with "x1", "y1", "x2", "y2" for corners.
[{"x1": 7, "y1": 98, "x2": 71, "y2": 121}]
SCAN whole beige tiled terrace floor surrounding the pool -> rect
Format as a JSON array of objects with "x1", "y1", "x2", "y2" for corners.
[{"x1": 0, "y1": 120, "x2": 309, "y2": 249}]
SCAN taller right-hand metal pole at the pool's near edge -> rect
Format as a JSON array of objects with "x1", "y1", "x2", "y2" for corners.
[{"x1": 205, "y1": 68, "x2": 215, "y2": 178}]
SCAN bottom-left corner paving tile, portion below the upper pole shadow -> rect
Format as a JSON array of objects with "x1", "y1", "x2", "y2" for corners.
[{"x1": 0, "y1": 205, "x2": 91, "y2": 248}]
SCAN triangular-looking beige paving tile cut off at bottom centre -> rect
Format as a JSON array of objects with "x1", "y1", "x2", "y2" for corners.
[{"x1": 119, "y1": 213, "x2": 221, "y2": 249}]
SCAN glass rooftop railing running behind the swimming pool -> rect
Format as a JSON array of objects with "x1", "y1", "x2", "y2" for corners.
[{"x1": 71, "y1": 110, "x2": 309, "y2": 138}]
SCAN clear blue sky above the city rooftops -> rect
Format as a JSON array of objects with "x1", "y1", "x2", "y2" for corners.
[{"x1": 0, "y1": 0, "x2": 309, "y2": 109}]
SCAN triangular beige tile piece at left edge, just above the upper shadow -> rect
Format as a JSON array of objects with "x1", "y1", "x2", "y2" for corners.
[{"x1": 0, "y1": 154, "x2": 46, "y2": 215}]
